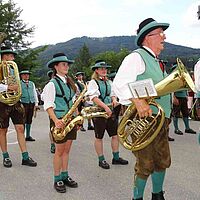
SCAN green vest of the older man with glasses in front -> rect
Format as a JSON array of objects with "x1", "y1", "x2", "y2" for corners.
[{"x1": 135, "y1": 49, "x2": 171, "y2": 118}]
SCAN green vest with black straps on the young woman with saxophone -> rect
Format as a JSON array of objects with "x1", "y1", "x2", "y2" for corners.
[{"x1": 50, "y1": 77, "x2": 75, "y2": 118}]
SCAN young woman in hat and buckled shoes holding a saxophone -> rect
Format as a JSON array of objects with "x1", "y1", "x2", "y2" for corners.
[{"x1": 42, "y1": 53, "x2": 78, "y2": 193}]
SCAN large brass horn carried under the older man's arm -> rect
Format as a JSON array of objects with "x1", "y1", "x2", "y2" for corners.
[{"x1": 118, "y1": 58, "x2": 196, "y2": 151}]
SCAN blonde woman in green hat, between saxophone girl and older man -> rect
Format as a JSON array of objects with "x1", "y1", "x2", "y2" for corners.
[{"x1": 86, "y1": 60, "x2": 128, "y2": 169}]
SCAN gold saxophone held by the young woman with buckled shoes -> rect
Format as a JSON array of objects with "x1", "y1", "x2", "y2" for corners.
[{"x1": 51, "y1": 85, "x2": 87, "y2": 143}]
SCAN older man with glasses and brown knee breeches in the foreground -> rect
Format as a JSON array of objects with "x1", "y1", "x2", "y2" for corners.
[{"x1": 113, "y1": 18, "x2": 171, "y2": 200}]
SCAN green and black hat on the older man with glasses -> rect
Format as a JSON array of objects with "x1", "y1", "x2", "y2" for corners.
[{"x1": 135, "y1": 18, "x2": 169, "y2": 46}]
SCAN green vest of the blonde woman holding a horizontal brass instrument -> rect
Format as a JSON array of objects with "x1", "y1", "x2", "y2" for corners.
[{"x1": 95, "y1": 80, "x2": 111, "y2": 104}]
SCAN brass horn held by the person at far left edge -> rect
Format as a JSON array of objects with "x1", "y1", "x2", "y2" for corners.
[{"x1": 0, "y1": 61, "x2": 22, "y2": 106}]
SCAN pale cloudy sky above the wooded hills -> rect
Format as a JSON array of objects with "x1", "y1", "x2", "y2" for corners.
[{"x1": 13, "y1": 0, "x2": 200, "y2": 48}]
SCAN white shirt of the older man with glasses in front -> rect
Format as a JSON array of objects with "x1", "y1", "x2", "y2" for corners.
[{"x1": 113, "y1": 46, "x2": 155, "y2": 105}]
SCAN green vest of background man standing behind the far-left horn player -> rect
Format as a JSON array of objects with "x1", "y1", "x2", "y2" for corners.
[{"x1": 20, "y1": 80, "x2": 35, "y2": 103}]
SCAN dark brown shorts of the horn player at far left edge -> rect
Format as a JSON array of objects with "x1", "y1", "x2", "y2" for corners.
[{"x1": 0, "y1": 102, "x2": 25, "y2": 128}]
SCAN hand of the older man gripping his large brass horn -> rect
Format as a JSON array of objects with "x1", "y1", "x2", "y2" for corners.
[{"x1": 133, "y1": 99, "x2": 152, "y2": 118}]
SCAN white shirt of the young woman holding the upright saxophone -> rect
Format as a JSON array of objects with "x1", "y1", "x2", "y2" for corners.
[{"x1": 41, "y1": 74, "x2": 70, "y2": 110}]
